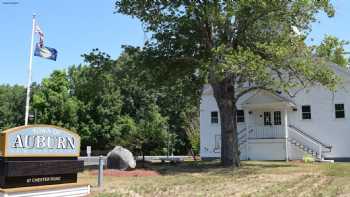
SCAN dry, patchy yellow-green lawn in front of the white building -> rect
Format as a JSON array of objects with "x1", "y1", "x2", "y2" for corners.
[{"x1": 79, "y1": 161, "x2": 350, "y2": 197}]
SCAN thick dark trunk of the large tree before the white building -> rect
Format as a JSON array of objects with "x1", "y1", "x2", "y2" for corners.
[{"x1": 212, "y1": 80, "x2": 240, "y2": 167}]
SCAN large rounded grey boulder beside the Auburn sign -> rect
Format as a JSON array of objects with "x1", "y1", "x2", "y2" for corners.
[{"x1": 107, "y1": 146, "x2": 136, "y2": 170}]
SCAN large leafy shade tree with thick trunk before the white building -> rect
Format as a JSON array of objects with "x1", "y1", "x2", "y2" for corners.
[{"x1": 116, "y1": 0, "x2": 346, "y2": 166}]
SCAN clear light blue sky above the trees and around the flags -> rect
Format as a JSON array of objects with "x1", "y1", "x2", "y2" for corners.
[{"x1": 0, "y1": 0, "x2": 350, "y2": 85}]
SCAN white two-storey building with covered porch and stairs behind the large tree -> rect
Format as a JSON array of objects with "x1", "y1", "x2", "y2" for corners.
[{"x1": 200, "y1": 65, "x2": 350, "y2": 161}]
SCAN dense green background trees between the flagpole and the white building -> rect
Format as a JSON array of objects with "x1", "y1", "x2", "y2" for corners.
[{"x1": 19, "y1": 50, "x2": 198, "y2": 154}]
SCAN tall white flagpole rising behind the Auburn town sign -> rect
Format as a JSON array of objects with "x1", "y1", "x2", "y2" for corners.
[{"x1": 24, "y1": 14, "x2": 35, "y2": 126}]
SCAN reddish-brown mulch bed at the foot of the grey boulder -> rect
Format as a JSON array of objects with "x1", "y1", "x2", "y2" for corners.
[{"x1": 91, "y1": 169, "x2": 160, "y2": 177}]
